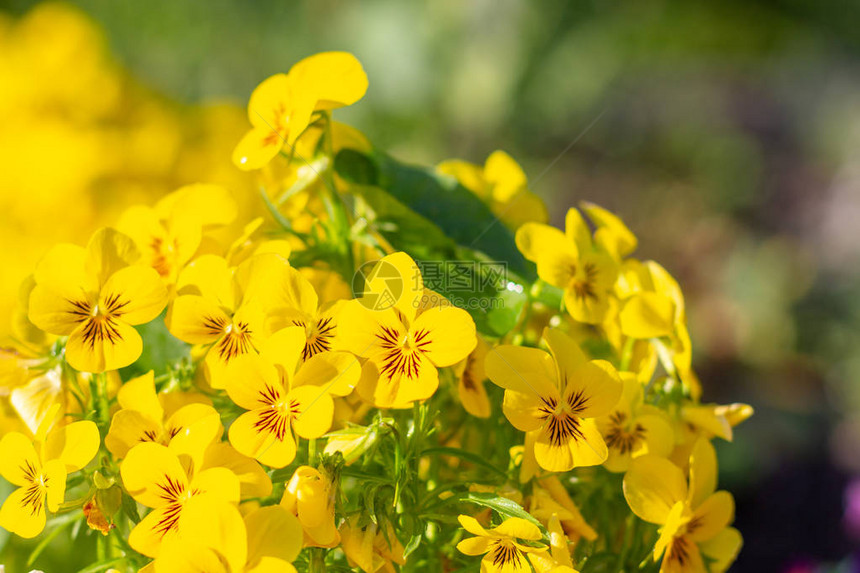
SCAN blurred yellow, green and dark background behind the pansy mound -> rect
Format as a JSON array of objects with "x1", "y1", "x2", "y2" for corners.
[{"x1": 0, "y1": 0, "x2": 860, "y2": 573}]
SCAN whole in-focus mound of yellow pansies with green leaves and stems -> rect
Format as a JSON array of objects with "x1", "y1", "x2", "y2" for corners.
[{"x1": 0, "y1": 52, "x2": 752, "y2": 573}]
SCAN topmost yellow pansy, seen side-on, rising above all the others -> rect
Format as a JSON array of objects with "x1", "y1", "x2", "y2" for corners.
[{"x1": 233, "y1": 52, "x2": 367, "y2": 170}]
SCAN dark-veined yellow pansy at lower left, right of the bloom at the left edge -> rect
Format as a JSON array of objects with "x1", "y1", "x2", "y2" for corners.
[{"x1": 120, "y1": 442, "x2": 239, "y2": 557}]
